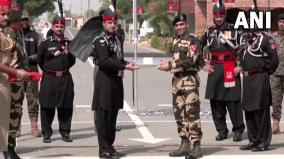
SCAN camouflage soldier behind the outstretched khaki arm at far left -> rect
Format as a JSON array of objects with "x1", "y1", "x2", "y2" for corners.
[{"x1": 5, "y1": 3, "x2": 28, "y2": 159}]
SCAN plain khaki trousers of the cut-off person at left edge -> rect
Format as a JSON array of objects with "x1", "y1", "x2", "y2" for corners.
[{"x1": 0, "y1": 73, "x2": 11, "y2": 152}]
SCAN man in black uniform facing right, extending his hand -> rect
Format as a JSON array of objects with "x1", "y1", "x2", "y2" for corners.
[{"x1": 92, "y1": 8, "x2": 138, "y2": 158}]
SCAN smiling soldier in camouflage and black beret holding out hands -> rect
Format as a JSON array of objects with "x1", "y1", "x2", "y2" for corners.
[{"x1": 157, "y1": 14, "x2": 205, "y2": 158}]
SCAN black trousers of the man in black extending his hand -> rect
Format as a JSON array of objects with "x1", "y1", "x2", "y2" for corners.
[{"x1": 95, "y1": 106, "x2": 118, "y2": 153}]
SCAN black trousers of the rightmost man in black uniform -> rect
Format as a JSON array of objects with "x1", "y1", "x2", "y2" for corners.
[{"x1": 245, "y1": 107, "x2": 272, "y2": 147}]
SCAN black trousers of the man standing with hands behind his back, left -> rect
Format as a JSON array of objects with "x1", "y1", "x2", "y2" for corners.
[{"x1": 40, "y1": 108, "x2": 73, "y2": 136}]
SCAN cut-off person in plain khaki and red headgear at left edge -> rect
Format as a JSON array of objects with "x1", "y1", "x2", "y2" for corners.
[{"x1": 0, "y1": 0, "x2": 27, "y2": 159}]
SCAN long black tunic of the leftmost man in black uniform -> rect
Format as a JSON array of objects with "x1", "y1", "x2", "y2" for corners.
[{"x1": 37, "y1": 36, "x2": 76, "y2": 108}]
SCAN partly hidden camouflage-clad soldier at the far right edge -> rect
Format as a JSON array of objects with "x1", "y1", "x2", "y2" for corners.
[{"x1": 270, "y1": 13, "x2": 284, "y2": 134}]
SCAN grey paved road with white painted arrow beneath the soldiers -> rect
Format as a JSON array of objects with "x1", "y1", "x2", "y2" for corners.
[{"x1": 13, "y1": 27, "x2": 284, "y2": 159}]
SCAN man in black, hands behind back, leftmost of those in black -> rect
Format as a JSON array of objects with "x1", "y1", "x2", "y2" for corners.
[{"x1": 37, "y1": 15, "x2": 76, "y2": 143}]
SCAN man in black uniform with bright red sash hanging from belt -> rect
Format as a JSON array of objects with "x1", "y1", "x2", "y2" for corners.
[{"x1": 201, "y1": 2, "x2": 245, "y2": 142}]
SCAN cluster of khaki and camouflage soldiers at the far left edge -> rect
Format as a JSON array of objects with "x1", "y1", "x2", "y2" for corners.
[{"x1": 0, "y1": 0, "x2": 41, "y2": 159}]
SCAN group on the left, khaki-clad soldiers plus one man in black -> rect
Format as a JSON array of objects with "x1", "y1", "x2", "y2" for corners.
[{"x1": 0, "y1": 0, "x2": 75, "y2": 159}]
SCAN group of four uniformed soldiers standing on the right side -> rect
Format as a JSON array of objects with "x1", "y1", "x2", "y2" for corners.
[{"x1": 157, "y1": 1, "x2": 284, "y2": 159}]
